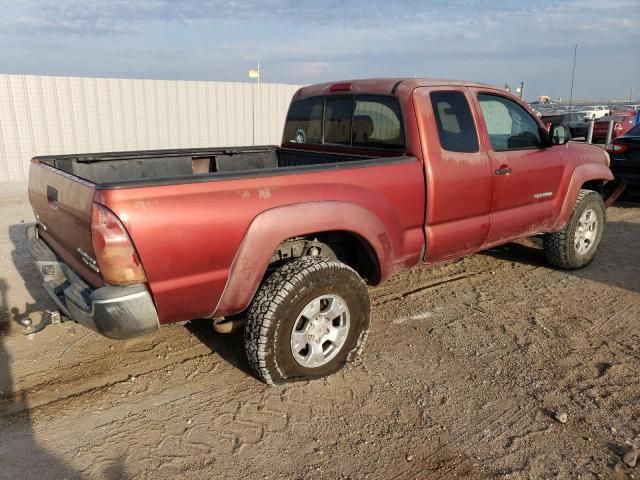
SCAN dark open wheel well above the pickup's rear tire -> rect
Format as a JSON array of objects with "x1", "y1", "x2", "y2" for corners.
[{"x1": 269, "y1": 231, "x2": 380, "y2": 285}]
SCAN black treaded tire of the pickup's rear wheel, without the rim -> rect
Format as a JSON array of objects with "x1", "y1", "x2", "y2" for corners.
[{"x1": 244, "y1": 256, "x2": 371, "y2": 385}]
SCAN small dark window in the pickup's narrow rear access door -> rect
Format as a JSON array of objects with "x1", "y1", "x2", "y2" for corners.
[{"x1": 429, "y1": 92, "x2": 478, "y2": 152}]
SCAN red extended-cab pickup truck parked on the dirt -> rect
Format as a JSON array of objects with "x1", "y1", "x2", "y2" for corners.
[{"x1": 28, "y1": 78, "x2": 613, "y2": 384}]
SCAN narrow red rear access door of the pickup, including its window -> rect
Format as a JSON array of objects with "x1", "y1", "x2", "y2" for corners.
[{"x1": 413, "y1": 86, "x2": 492, "y2": 263}]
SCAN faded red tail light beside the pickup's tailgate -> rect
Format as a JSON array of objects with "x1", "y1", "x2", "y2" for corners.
[{"x1": 91, "y1": 203, "x2": 147, "y2": 285}]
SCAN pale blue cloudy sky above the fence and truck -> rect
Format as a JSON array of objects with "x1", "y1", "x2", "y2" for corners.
[{"x1": 0, "y1": 0, "x2": 640, "y2": 100}]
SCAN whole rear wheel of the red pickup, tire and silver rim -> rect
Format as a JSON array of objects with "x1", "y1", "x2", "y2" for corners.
[{"x1": 244, "y1": 257, "x2": 370, "y2": 385}]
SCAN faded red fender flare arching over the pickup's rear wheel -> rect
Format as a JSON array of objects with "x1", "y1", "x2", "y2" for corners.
[{"x1": 212, "y1": 201, "x2": 399, "y2": 316}]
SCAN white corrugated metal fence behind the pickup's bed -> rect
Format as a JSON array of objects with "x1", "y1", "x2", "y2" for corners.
[{"x1": 0, "y1": 74, "x2": 299, "y2": 182}]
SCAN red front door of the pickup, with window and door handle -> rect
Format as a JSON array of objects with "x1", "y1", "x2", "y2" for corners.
[{"x1": 474, "y1": 89, "x2": 563, "y2": 245}]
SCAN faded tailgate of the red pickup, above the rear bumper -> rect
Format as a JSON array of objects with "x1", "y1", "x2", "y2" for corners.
[{"x1": 29, "y1": 160, "x2": 104, "y2": 287}]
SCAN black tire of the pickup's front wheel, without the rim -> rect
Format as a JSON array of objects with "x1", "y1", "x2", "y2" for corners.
[{"x1": 544, "y1": 190, "x2": 606, "y2": 270}]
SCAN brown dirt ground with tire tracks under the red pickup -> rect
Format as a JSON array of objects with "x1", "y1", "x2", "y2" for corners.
[{"x1": 0, "y1": 185, "x2": 640, "y2": 479}]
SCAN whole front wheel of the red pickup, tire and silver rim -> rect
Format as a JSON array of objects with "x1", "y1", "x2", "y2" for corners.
[{"x1": 544, "y1": 190, "x2": 606, "y2": 270}]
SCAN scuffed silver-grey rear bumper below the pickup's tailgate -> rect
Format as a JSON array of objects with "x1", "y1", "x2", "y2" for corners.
[{"x1": 27, "y1": 225, "x2": 160, "y2": 339}]
